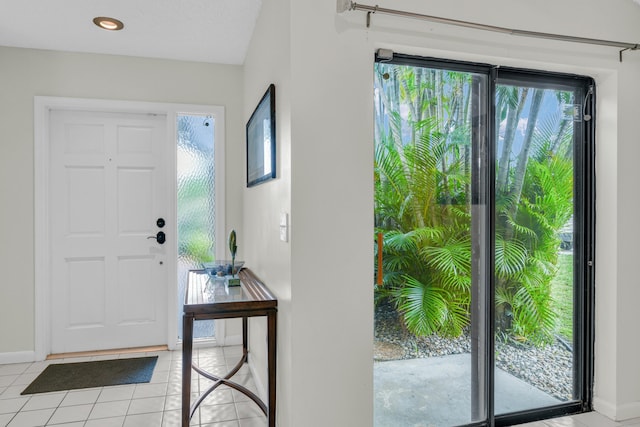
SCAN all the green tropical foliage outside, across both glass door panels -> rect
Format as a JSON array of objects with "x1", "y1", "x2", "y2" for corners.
[{"x1": 374, "y1": 63, "x2": 573, "y2": 343}]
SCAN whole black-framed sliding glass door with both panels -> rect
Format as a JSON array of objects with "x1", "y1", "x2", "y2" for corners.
[{"x1": 374, "y1": 55, "x2": 593, "y2": 427}]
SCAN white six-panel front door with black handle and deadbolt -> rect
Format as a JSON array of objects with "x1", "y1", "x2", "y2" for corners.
[{"x1": 49, "y1": 110, "x2": 171, "y2": 353}]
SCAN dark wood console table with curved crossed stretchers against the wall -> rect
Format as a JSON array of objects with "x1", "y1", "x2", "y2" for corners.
[{"x1": 182, "y1": 268, "x2": 278, "y2": 427}]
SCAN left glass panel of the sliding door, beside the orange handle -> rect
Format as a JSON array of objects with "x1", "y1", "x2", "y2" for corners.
[{"x1": 374, "y1": 63, "x2": 488, "y2": 427}]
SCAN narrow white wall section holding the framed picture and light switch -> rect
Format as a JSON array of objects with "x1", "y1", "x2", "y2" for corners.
[{"x1": 241, "y1": 0, "x2": 297, "y2": 426}]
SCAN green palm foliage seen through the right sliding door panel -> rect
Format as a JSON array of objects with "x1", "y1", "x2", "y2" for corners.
[{"x1": 495, "y1": 89, "x2": 573, "y2": 343}]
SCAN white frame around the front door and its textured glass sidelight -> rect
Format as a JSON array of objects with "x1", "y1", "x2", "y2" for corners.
[{"x1": 34, "y1": 96, "x2": 226, "y2": 360}]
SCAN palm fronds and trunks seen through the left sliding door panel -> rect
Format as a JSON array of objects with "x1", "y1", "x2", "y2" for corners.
[{"x1": 375, "y1": 64, "x2": 471, "y2": 335}]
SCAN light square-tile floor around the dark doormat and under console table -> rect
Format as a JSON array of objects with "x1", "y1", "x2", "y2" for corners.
[{"x1": 0, "y1": 346, "x2": 267, "y2": 427}]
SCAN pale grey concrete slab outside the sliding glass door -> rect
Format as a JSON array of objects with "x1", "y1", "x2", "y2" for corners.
[{"x1": 373, "y1": 354, "x2": 560, "y2": 427}]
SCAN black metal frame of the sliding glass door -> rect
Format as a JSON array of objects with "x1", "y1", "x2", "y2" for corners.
[{"x1": 376, "y1": 53, "x2": 596, "y2": 426}]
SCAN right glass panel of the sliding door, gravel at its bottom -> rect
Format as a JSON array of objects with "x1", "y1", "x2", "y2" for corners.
[{"x1": 494, "y1": 79, "x2": 583, "y2": 414}]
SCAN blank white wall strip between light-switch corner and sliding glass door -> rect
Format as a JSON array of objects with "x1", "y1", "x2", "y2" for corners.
[{"x1": 291, "y1": 0, "x2": 374, "y2": 427}]
